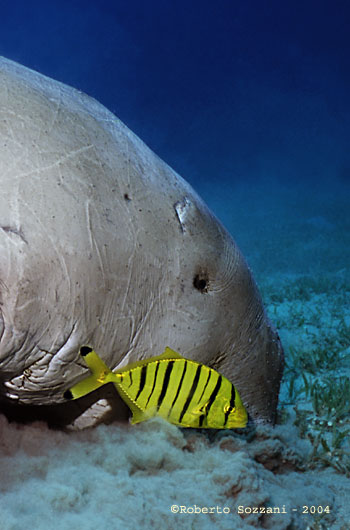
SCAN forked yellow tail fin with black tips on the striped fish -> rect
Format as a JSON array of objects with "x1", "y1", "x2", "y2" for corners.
[{"x1": 64, "y1": 346, "x2": 114, "y2": 399}]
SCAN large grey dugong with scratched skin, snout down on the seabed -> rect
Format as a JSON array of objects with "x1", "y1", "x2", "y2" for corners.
[{"x1": 0, "y1": 58, "x2": 283, "y2": 422}]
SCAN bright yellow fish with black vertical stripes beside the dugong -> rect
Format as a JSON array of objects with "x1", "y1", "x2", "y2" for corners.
[{"x1": 64, "y1": 346, "x2": 248, "y2": 429}]
